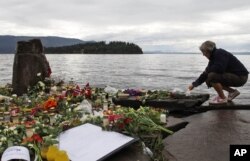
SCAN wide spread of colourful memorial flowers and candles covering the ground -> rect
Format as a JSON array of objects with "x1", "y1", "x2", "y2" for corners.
[{"x1": 0, "y1": 80, "x2": 172, "y2": 161}]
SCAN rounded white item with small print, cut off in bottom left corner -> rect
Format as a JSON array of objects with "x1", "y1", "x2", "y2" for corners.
[{"x1": 1, "y1": 146, "x2": 30, "y2": 161}]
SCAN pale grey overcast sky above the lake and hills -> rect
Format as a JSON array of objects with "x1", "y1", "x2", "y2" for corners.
[{"x1": 0, "y1": 0, "x2": 250, "y2": 52}]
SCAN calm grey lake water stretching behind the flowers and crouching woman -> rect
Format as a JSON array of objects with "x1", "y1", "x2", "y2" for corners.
[{"x1": 0, "y1": 54, "x2": 250, "y2": 104}]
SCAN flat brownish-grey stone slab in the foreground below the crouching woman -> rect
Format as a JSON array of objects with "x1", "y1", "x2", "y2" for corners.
[{"x1": 164, "y1": 109, "x2": 250, "y2": 161}]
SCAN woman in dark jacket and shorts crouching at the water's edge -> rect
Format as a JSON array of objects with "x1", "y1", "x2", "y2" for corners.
[{"x1": 188, "y1": 41, "x2": 249, "y2": 104}]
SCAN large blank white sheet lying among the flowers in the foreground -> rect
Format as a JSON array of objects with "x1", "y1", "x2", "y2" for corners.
[{"x1": 59, "y1": 123, "x2": 134, "y2": 161}]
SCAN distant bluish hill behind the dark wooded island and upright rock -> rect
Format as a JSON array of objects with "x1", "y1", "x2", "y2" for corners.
[{"x1": 0, "y1": 35, "x2": 90, "y2": 54}]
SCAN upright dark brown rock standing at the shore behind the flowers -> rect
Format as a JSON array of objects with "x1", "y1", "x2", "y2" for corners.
[{"x1": 12, "y1": 39, "x2": 51, "y2": 96}]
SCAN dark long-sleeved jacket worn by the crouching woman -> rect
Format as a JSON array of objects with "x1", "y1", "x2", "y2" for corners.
[{"x1": 192, "y1": 49, "x2": 249, "y2": 87}]
